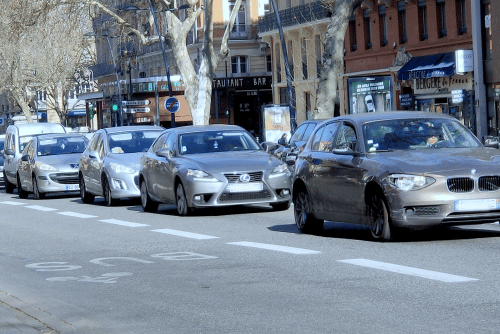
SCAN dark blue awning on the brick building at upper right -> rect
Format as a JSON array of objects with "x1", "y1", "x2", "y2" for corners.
[{"x1": 398, "y1": 52, "x2": 455, "y2": 80}]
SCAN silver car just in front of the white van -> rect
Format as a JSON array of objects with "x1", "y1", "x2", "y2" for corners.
[{"x1": 17, "y1": 133, "x2": 88, "y2": 199}]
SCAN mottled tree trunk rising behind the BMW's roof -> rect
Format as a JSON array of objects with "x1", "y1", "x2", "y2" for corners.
[{"x1": 313, "y1": 0, "x2": 363, "y2": 118}]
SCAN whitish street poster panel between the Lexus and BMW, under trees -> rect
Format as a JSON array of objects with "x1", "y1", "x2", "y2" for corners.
[{"x1": 262, "y1": 105, "x2": 291, "y2": 143}]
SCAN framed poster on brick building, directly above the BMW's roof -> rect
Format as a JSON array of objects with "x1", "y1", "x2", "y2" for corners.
[{"x1": 348, "y1": 76, "x2": 393, "y2": 114}]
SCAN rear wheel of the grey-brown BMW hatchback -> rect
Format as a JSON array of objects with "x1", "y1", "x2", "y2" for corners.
[{"x1": 293, "y1": 188, "x2": 323, "y2": 234}]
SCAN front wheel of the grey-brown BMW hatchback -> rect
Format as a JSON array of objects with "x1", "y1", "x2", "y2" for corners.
[{"x1": 368, "y1": 191, "x2": 394, "y2": 241}]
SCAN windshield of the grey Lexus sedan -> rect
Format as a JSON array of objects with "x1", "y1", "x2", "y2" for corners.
[{"x1": 179, "y1": 130, "x2": 261, "y2": 154}]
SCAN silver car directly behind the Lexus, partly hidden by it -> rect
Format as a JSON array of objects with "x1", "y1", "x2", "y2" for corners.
[{"x1": 78, "y1": 125, "x2": 165, "y2": 206}]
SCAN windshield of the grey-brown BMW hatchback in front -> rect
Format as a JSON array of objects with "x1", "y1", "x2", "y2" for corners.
[{"x1": 363, "y1": 118, "x2": 481, "y2": 152}]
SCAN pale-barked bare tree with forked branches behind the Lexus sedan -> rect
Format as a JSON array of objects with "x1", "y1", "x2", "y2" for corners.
[{"x1": 81, "y1": 0, "x2": 241, "y2": 125}]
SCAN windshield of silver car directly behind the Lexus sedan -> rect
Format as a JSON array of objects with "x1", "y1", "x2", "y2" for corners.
[{"x1": 108, "y1": 130, "x2": 163, "y2": 154}]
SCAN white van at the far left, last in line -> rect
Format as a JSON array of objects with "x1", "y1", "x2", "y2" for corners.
[{"x1": 3, "y1": 123, "x2": 66, "y2": 193}]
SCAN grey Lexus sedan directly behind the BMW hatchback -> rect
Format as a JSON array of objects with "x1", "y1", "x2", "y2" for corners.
[{"x1": 139, "y1": 125, "x2": 291, "y2": 215}]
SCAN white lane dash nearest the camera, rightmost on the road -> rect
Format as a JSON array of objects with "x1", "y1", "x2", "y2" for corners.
[{"x1": 337, "y1": 259, "x2": 478, "y2": 283}]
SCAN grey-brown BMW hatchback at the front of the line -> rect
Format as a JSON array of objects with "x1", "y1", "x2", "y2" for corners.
[{"x1": 293, "y1": 112, "x2": 500, "y2": 240}]
